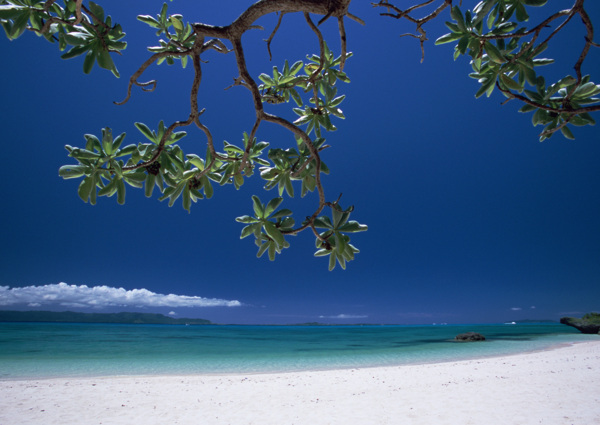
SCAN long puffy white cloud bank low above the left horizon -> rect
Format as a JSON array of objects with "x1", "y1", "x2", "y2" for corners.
[{"x1": 0, "y1": 282, "x2": 241, "y2": 308}]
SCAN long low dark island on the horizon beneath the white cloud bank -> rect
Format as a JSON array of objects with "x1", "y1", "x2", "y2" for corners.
[{"x1": 0, "y1": 311, "x2": 212, "y2": 325}]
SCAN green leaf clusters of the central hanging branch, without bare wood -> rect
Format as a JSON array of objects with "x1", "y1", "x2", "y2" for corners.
[{"x1": 54, "y1": 4, "x2": 366, "y2": 269}]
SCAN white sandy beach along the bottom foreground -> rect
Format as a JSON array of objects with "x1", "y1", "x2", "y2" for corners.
[{"x1": 0, "y1": 340, "x2": 600, "y2": 425}]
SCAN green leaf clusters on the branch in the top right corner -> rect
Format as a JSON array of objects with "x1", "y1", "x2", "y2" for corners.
[{"x1": 436, "y1": 0, "x2": 600, "y2": 141}]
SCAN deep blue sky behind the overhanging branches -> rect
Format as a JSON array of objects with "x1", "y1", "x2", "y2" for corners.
[{"x1": 0, "y1": 0, "x2": 600, "y2": 323}]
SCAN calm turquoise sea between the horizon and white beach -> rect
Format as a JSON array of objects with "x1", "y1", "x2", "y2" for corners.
[{"x1": 0, "y1": 323, "x2": 598, "y2": 379}]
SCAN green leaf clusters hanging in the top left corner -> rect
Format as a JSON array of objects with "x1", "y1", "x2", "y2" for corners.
[{"x1": 0, "y1": 0, "x2": 127, "y2": 77}]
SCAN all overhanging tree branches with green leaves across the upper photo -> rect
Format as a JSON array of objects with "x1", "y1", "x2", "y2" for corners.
[{"x1": 0, "y1": 0, "x2": 600, "y2": 270}]
